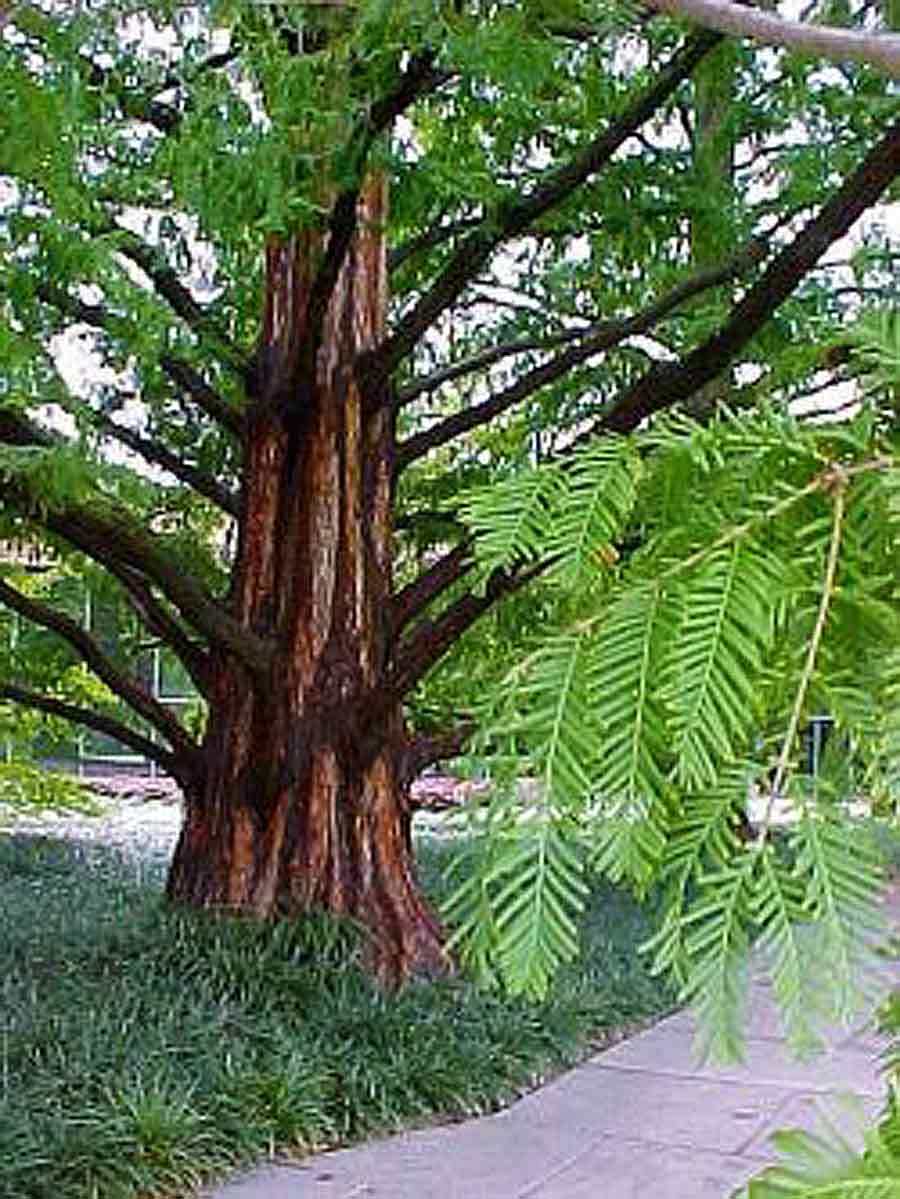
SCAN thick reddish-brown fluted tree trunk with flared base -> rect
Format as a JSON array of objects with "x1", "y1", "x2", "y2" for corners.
[{"x1": 168, "y1": 180, "x2": 447, "y2": 983}]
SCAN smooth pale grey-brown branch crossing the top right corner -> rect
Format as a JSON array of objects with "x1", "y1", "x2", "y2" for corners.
[{"x1": 646, "y1": 0, "x2": 900, "y2": 78}]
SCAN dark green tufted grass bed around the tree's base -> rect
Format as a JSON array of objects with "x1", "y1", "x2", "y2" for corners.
[{"x1": 0, "y1": 837, "x2": 671, "y2": 1199}]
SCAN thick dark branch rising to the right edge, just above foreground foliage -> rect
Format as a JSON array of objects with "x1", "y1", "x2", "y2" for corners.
[{"x1": 598, "y1": 116, "x2": 900, "y2": 433}]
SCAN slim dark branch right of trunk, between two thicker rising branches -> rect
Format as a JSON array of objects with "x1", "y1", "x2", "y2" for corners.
[{"x1": 397, "y1": 241, "x2": 765, "y2": 472}]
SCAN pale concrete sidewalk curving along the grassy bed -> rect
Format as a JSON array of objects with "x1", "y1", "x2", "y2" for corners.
[{"x1": 202, "y1": 954, "x2": 895, "y2": 1199}]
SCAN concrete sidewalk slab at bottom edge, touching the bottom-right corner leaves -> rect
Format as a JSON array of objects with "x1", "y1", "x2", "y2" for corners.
[{"x1": 517, "y1": 1138, "x2": 767, "y2": 1199}]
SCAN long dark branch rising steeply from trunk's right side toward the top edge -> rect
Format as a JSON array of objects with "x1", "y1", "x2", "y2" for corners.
[{"x1": 364, "y1": 31, "x2": 721, "y2": 376}]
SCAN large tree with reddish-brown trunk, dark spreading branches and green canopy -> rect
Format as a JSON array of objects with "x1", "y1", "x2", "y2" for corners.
[{"x1": 0, "y1": 0, "x2": 900, "y2": 980}]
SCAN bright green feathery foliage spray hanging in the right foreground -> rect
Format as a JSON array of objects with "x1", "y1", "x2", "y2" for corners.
[{"x1": 448, "y1": 378, "x2": 900, "y2": 1056}]
